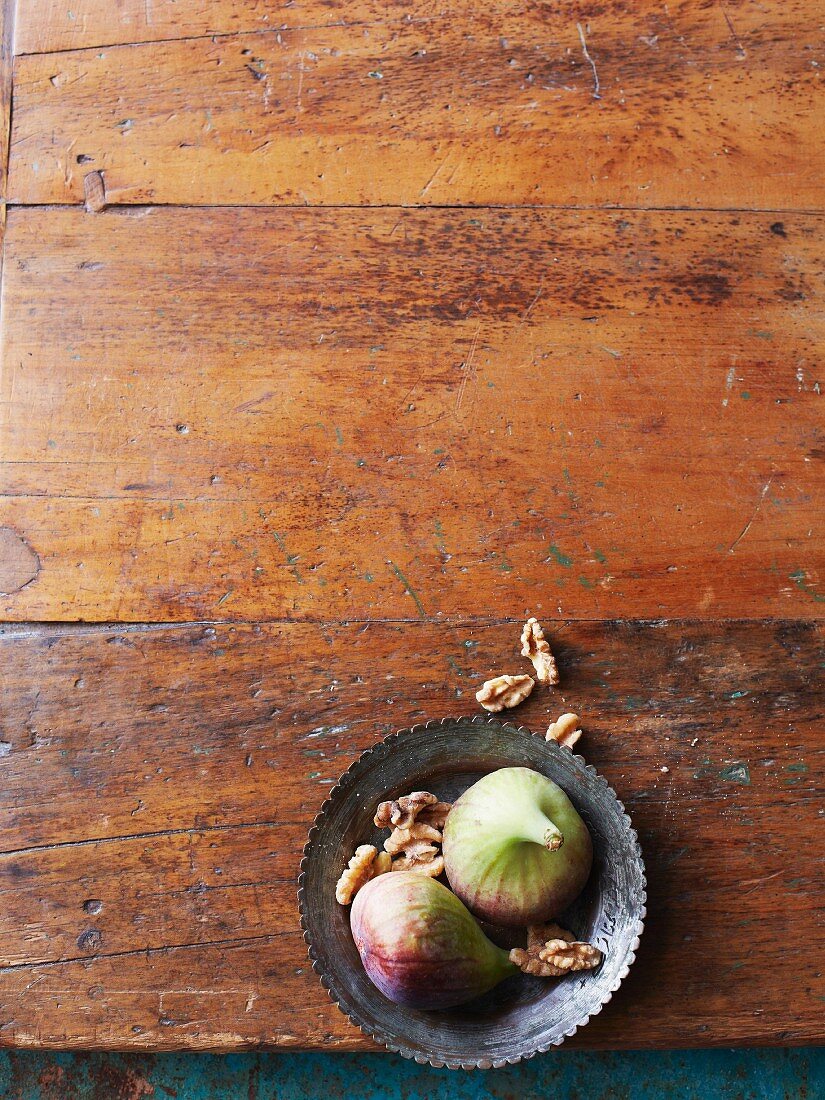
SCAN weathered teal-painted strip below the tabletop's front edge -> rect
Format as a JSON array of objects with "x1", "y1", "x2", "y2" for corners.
[{"x1": 0, "y1": 1047, "x2": 825, "y2": 1100}]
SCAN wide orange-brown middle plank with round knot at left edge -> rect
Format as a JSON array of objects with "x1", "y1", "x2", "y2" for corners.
[{"x1": 0, "y1": 209, "x2": 825, "y2": 620}]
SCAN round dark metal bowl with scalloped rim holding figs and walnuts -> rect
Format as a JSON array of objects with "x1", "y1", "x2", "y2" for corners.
[{"x1": 298, "y1": 717, "x2": 646, "y2": 1069}]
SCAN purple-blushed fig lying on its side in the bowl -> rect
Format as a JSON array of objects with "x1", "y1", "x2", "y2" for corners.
[{"x1": 350, "y1": 871, "x2": 518, "y2": 1009}]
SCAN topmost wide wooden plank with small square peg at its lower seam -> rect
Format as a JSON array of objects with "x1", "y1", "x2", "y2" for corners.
[{"x1": 10, "y1": 0, "x2": 825, "y2": 209}]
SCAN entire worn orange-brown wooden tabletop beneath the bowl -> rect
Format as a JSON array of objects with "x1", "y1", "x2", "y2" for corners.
[{"x1": 0, "y1": 0, "x2": 825, "y2": 1049}]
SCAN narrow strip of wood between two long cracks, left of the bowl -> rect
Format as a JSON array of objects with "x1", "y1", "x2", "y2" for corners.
[{"x1": 0, "y1": 822, "x2": 307, "y2": 967}]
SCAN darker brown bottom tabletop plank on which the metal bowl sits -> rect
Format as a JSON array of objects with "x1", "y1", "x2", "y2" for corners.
[{"x1": 0, "y1": 623, "x2": 825, "y2": 1049}]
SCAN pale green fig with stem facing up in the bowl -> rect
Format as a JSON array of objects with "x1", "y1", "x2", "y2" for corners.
[{"x1": 443, "y1": 768, "x2": 593, "y2": 926}]
